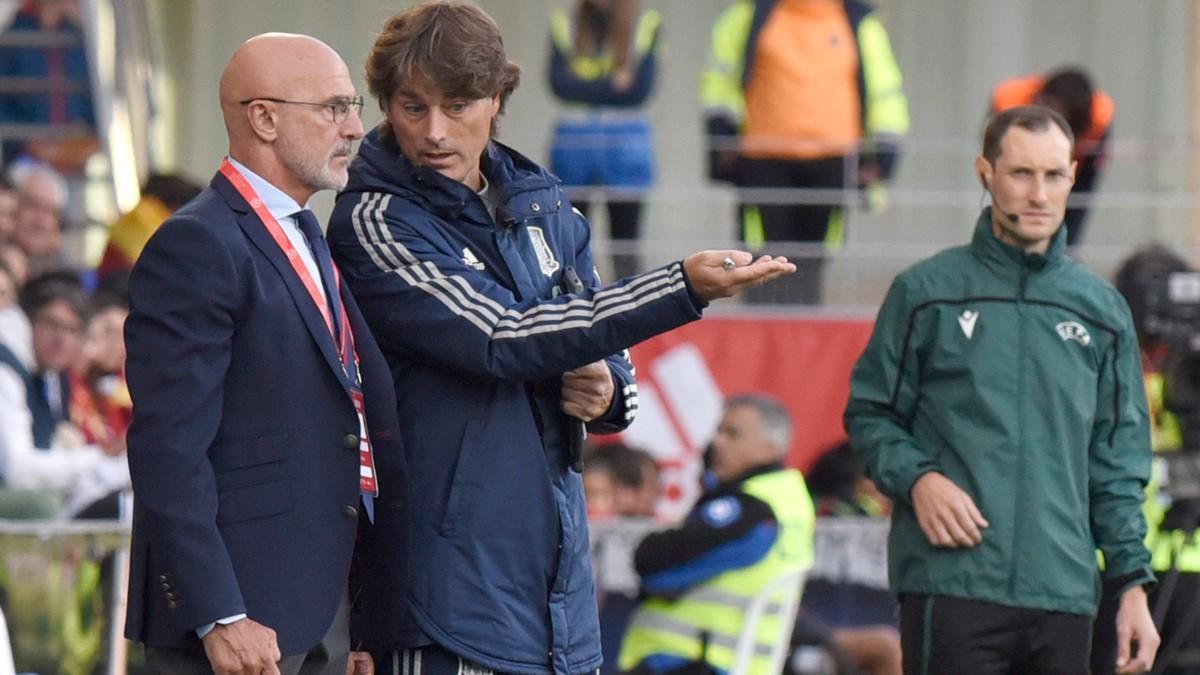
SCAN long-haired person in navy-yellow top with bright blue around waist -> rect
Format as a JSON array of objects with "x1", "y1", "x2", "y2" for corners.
[{"x1": 550, "y1": 0, "x2": 662, "y2": 279}]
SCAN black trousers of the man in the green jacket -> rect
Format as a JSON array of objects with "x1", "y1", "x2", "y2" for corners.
[{"x1": 900, "y1": 593, "x2": 1092, "y2": 675}]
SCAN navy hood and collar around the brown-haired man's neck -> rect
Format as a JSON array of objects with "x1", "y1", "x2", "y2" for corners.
[{"x1": 343, "y1": 126, "x2": 559, "y2": 217}]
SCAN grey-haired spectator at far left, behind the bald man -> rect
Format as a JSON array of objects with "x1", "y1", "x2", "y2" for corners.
[{"x1": 8, "y1": 161, "x2": 67, "y2": 276}]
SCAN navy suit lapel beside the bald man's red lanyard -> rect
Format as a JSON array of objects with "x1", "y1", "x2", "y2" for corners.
[{"x1": 212, "y1": 173, "x2": 348, "y2": 388}]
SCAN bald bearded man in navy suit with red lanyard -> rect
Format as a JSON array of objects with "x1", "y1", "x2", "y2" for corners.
[{"x1": 126, "y1": 34, "x2": 404, "y2": 675}]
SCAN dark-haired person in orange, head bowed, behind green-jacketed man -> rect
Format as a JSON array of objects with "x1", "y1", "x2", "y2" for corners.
[{"x1": 991, "y1": 67, "x2": 1116, "y2": 247}]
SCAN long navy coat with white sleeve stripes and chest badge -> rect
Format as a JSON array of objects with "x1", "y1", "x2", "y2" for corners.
[{"x1": 329, "y1": 130, "x2": 701, "y2": 674}]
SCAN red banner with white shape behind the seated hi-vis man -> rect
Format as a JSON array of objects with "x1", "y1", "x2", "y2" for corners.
[{"x1": 604, "y1": 316, "x2": 872, "y2": 514}]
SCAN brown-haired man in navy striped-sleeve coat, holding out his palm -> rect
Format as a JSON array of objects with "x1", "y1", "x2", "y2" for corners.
[{"x1": 329, "y1": 1, "x2": 794, "y2": 675}]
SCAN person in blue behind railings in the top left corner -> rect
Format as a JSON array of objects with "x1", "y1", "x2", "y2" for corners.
[{"x1": 0, "y1": 0, "x2": 98, "y2": 170}]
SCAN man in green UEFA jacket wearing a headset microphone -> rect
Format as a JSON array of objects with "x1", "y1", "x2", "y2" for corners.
[{"x1": 845, "y1": 106, "x2": 1158, "y2": 673}]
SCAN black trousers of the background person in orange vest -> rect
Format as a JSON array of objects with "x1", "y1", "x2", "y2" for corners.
[{"x1": 734, "y1": 157, "x2": 846, "y2": 305}]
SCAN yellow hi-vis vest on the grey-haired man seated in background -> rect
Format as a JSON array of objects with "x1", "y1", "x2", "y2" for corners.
[{"x1": 617, "y1": 468, "x2": 816, "y2": 675}]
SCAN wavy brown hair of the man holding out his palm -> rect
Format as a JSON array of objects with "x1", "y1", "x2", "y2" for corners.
[{"x1": 366, "y1": 0, "x2": 521, "y2": 136}]
